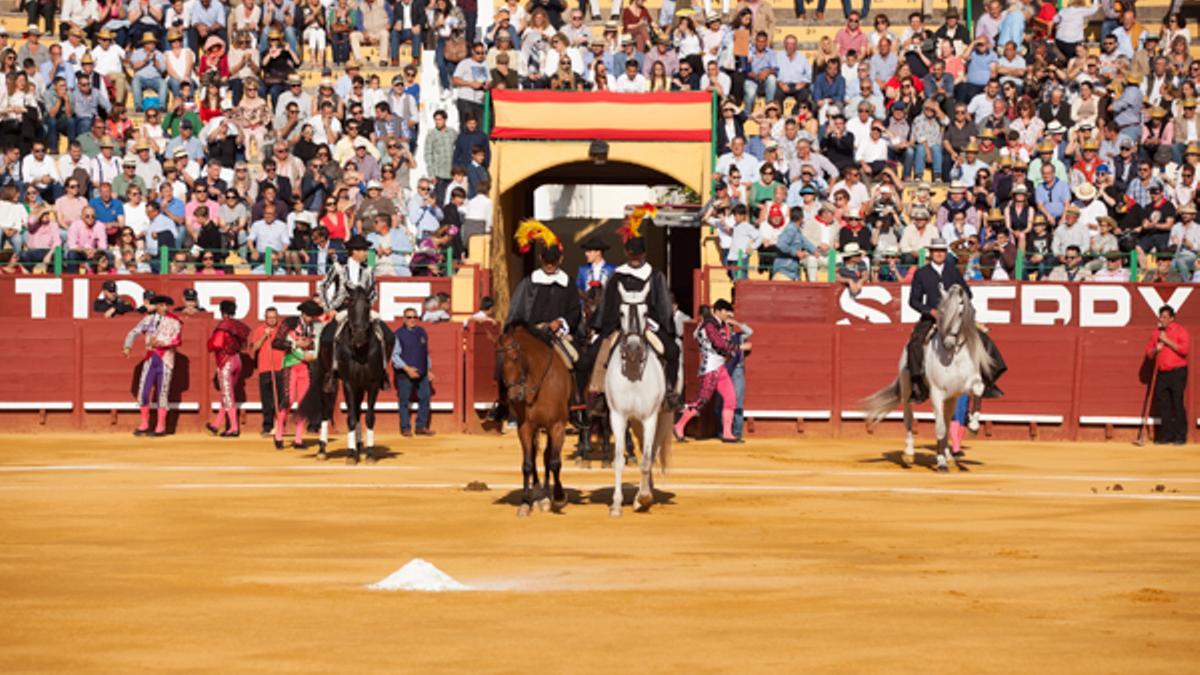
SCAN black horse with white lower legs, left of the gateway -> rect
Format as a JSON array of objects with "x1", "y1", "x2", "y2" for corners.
[{"x1": 300, "y1": 283, "x2": 404, "y2": 464}]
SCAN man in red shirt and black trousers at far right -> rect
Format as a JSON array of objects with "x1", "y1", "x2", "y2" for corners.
[{"x1": 1146, "y1": 305, "x2": 1192, "y2": 446}]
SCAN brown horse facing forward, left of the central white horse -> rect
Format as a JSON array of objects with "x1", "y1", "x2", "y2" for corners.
[{"x1": 496, "y1": 324, "x2": 572, "y2": 516}]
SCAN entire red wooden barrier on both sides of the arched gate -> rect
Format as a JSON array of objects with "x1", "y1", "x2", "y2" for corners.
[{"x1": 0, "y1": 276, "x2": 1200, "y2": 438}]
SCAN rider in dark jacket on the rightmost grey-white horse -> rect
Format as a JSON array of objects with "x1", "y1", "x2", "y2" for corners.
[{"x1": 905, "y1": 238, "x2": 1008, "y2": 402}]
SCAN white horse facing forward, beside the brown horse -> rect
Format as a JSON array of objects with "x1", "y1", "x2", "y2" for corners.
[{"x1": 604, "y1": 283, "x2": 671, "y2": 518}]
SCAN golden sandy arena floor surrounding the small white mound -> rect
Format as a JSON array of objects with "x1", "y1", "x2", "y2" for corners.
[{"x1": 0, "y1": 427, "x2": 1200, "y2": 674}]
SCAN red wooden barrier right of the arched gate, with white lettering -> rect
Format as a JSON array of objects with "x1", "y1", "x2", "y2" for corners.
[{"x1": 684, "y1": 282, "x2": 1200, "y2": 438}]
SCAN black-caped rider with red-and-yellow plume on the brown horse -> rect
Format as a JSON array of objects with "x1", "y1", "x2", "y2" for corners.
[{"x1": 505, "y1": 221, "x2": 582, "y2": 424}]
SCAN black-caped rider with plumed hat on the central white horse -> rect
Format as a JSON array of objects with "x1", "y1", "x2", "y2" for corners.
[{"x1": 588, "y1": 228, "x2": 679, "y2": 417}]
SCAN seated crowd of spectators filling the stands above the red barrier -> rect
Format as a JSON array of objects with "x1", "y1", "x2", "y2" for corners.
[{"x1": 0, "y1": 0, "x2": 1200, "y2": 286}]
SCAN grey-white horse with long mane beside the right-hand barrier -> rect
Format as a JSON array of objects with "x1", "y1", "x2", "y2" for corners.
[{"x1": 864, "y1": 286, "x2": 995, "y2": 472}]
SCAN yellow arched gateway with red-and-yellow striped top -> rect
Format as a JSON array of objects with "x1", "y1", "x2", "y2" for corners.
[{"x1": 469, "y1": 90, "x2": 715, "y2": 309}]
